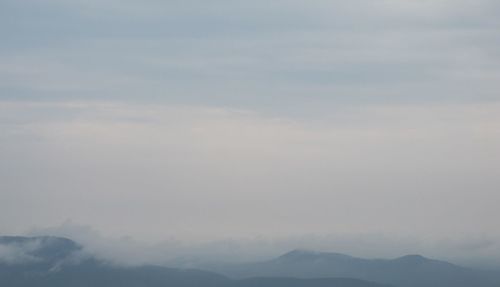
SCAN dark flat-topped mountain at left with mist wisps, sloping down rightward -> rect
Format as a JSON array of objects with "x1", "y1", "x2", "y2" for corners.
[{"x1": 0, "y1": 237, "x2": 387, "y2": 287}]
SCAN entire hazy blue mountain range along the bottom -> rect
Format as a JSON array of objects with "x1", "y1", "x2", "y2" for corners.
[{"x1": 0, "y1": 237, "x2": 500, "y2": 287}]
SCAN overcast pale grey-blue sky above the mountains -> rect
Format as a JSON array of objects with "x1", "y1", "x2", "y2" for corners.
[{"x1": 0, "y1": 0, "x2": 500, "y2": 266}]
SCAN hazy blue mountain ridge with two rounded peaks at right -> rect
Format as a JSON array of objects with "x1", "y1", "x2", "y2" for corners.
[{"x1": 214, "y1": 250, "x2": 500, "y2": 287}]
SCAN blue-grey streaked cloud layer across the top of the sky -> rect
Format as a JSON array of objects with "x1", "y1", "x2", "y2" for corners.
[{"x1": 0, "y1": 0, "x2": 500, "y2": 114}]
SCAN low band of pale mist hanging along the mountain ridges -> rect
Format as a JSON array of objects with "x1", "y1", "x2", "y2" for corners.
[{"x1": 26, "y1": 221, "x2": 500, "y2": 269}]
